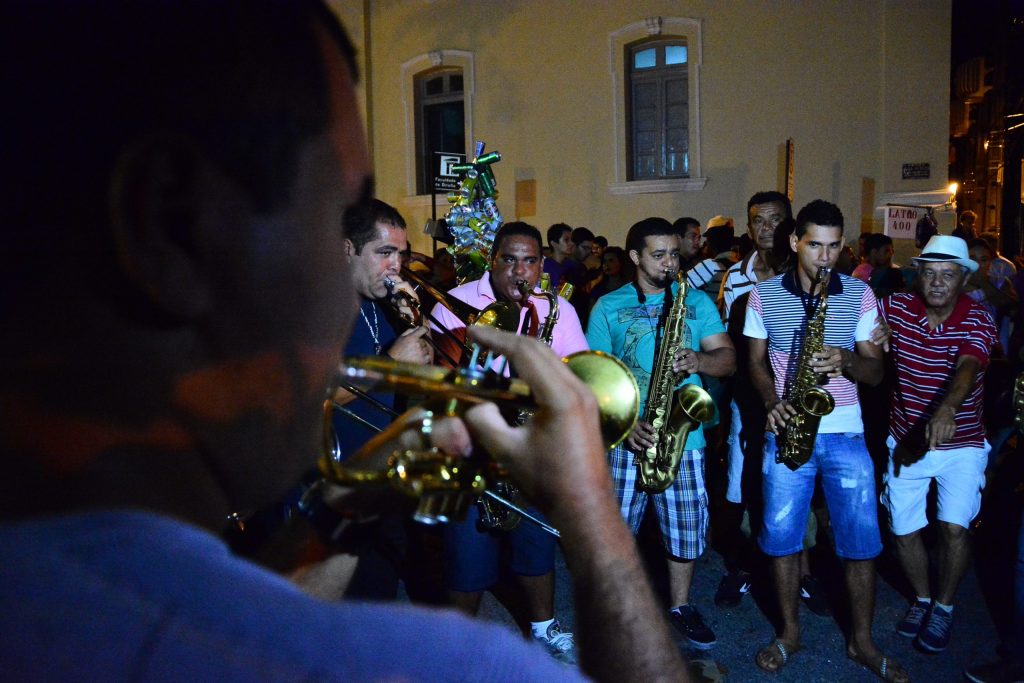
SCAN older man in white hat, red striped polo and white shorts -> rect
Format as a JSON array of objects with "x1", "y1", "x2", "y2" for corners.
[{"x1": 881, "y1": 234, "x2": 996, "y2": 652}]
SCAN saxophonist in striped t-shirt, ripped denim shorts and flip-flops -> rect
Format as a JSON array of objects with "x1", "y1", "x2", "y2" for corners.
[{"x1": 743, "y1": 200, "x2": 907, "y2": 681}]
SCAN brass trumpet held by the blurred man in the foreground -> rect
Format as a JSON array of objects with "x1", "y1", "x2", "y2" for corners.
[{"x1": 318, "y1": 351, "x2": 640, "y2": 523}]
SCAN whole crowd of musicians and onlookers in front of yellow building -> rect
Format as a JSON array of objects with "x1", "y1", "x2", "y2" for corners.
[{"x1": 0, "y1": 1, "x2": 1024, "y2": 681}]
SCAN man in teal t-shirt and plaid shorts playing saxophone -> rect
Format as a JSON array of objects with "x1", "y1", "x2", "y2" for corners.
[{"x1": 587, "y1": 218, "x2": 736, "y2": 649}]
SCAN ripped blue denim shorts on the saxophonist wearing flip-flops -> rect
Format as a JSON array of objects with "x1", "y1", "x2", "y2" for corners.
[{"x1": 758, "y1": 433, "x2": 882, "y2": 560}]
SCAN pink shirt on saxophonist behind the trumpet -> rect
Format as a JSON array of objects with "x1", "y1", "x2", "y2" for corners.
[{"x1": 430, "y1": 274, "x2": 590, "y2": 376}]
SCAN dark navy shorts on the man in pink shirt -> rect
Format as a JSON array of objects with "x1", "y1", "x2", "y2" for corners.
[{"x1": 443, "y1": 505, "x2": 557, "y2": 593}]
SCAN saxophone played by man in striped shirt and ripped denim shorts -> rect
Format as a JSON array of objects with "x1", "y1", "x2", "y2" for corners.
[{"x1": 775, "y1": 267, "x2": 836, "y2": 470}]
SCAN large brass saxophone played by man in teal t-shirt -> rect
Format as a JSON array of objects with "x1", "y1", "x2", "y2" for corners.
[{"x1": 634, "y1": 271, "x2": 715, "y2": 494}]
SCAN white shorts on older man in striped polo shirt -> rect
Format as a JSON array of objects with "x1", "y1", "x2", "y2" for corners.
[{"x1": 881, "y1": 436, "x2": 991, "y2": 536}]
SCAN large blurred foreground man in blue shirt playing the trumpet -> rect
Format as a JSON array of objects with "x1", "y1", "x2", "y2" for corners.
[{"x1": 0, "y1": 0, "x2": 686, "y2": 681}]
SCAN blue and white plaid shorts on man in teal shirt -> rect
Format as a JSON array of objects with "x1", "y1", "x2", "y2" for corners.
[{"x1": 608, "y1": 447, "x2": 708, "y2": 560}]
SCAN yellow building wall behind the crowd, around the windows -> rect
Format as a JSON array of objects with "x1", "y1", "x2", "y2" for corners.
[{"x1": 339, "y1": 0, "x2": 950, "y2": 250}]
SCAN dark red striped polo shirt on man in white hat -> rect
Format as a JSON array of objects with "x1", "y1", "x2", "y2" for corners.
[{"x1": 880, "y1": 293, "x2": 995, "y2": 451}]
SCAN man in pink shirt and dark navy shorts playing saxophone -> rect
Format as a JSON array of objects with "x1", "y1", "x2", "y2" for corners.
[{"x1": 431, "y1": 222, "x2": 588, "y2": 663}]
